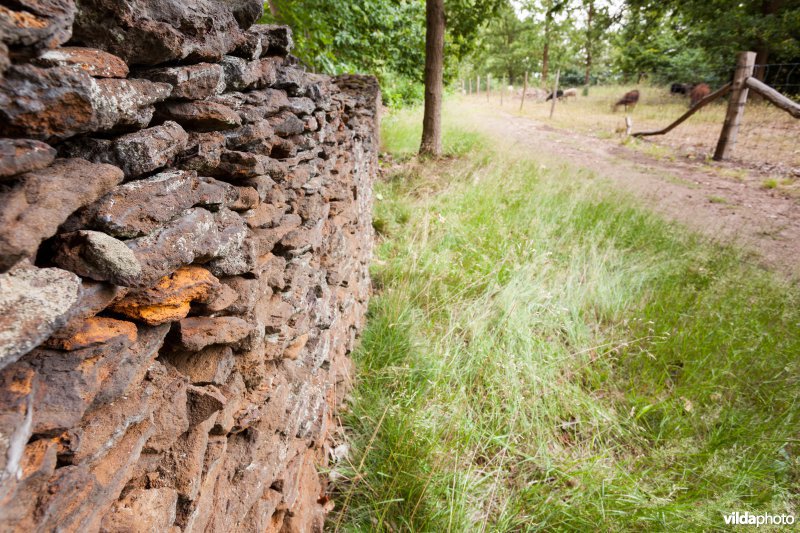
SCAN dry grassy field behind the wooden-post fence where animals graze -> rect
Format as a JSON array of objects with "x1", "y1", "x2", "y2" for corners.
[{"x1": 488, "y1": 85, "x2": 800, "y2": 175}]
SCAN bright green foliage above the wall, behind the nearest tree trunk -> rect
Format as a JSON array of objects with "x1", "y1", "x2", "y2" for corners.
[{"x1": 263, "y1": 0, "x2": 502, "y2": 106}]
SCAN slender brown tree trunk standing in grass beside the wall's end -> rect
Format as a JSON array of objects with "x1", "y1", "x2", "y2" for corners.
[{"x1": 419, "y1": 0, "x2": 444, "y2": 156}]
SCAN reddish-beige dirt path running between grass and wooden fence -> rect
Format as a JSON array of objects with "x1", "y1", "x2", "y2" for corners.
[{"x1": 467, "y1": 104, "x2": 800, "y2": 281}]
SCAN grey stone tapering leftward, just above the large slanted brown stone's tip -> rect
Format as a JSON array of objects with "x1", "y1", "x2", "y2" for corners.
[{"x1": 61, "y1": 121, "x2": 189, "y2": 178}]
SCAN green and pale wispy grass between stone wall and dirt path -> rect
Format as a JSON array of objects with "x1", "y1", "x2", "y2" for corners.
[{"x1": 328, "y1": 103, "x2": 800, "y2": 532}]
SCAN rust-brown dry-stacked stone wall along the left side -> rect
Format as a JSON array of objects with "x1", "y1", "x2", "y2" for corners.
[{"x1": 0, "y1": 0, "x2": 379, "y2": 532}]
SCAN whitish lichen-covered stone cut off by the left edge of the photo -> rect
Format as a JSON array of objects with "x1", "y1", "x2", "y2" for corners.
[{"x1": 0, "y1": 266, "x2": 81, "y2": 368}]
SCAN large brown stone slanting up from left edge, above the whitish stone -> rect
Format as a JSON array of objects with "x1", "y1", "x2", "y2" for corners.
[{"x1": 0, "y1": 159, "x2": 122, "y2": 271}]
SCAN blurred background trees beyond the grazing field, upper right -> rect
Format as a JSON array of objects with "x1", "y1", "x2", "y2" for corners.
[{"x1": 461, "y1": 0, "x2": 800, "y2": 86}]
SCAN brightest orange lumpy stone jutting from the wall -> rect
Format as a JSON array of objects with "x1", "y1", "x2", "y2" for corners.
[{"x1": 112, "y1": 266, "x2": 220, "y2": 326}]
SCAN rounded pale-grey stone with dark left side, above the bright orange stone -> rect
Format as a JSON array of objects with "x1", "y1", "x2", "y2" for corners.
[{"x1": 53, "y1": 230, "x2": 142, "y2": 285}]
